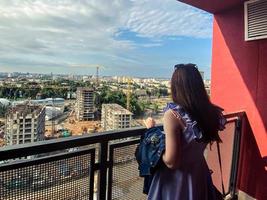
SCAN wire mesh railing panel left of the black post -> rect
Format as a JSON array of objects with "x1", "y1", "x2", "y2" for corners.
[{"x1": 0, "y1": 149, "x2": 94, "y2": 200}]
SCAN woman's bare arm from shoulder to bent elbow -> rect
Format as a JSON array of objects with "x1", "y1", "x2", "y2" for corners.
[{"x1": 163, "y1": 110, "x2": 182, "y2": 169}]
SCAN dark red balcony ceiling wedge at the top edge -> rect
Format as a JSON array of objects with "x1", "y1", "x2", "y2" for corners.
[{"x1": 178, "y1": 0, "x2": 245, "y2": 13}]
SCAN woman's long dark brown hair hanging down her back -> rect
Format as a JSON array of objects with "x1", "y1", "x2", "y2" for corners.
[{"x1": 171, "y1": 63, "x2": 223, "y2": 142}]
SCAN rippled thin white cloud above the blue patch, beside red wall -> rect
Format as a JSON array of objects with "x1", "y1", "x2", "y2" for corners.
[{"x1": 126, "y1": 0, "x2": 214, "y2": 38}]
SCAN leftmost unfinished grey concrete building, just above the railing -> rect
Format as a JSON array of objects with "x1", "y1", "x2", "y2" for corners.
[{"x1": 5, "y1": 104, "x2": 45, "y2": 145}]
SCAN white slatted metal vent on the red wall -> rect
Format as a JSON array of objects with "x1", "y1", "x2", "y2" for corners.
[{"x1": 244, "y1": 0, "x2": 267, "y2": 41}]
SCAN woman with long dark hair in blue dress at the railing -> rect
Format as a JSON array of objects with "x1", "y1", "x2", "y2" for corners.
[{"x1": 146, "y1": 64, "x2": 225, "y2": 200}]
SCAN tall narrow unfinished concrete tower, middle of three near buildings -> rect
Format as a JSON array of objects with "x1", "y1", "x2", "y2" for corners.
[{"x1": 75, "y1": 88, "x2": 94, "y2": 121}]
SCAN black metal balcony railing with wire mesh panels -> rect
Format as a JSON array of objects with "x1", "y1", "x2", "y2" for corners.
[{"x1": 0, "y1": 115, "x2": 245, "y2": 200}]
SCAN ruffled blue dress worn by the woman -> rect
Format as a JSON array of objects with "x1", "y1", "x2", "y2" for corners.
[{"x1": 147, "y1": 103, "x2": 217, "y2": 200}]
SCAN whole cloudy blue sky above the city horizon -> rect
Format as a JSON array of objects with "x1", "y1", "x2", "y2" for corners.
[{"x1": 0, "y1": 0, "x2": 212, "y2": 78}]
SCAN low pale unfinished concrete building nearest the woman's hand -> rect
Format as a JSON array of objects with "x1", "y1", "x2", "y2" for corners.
[{"x1": 101, "y1": 104, "x2": 133, "y2": 131}]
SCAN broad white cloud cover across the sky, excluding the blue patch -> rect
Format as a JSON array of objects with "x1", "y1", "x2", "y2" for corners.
[{"x1": 0, "y1": 0, "x2": 214, "y2": 72}]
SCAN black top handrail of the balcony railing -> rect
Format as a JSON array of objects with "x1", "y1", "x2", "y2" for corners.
[{"x1": 0, "y1": 111, "x2": 245, "y2": 160}]
